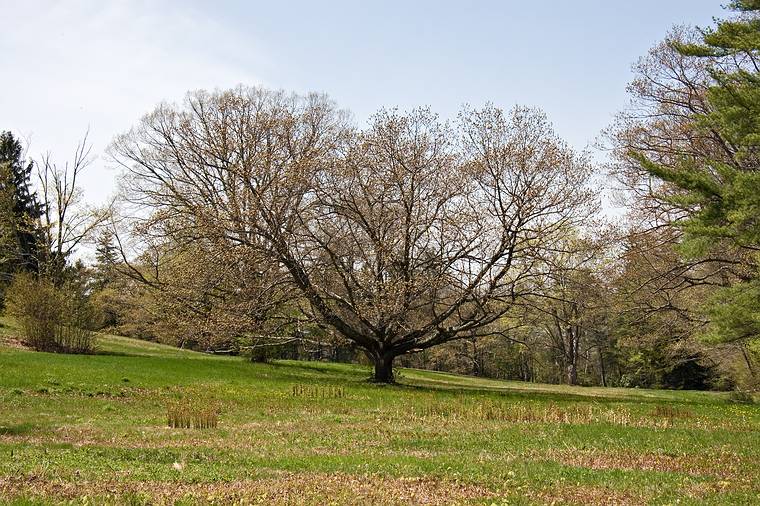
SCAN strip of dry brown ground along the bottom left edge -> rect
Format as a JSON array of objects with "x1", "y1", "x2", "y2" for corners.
[{"x1": 0, "y1": 472, "x2": 495, "y2": 505}]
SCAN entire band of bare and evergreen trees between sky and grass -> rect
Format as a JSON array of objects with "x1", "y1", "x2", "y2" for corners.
[{"x1": 0, "y1": 0, "x2": 760, "y2": 389}]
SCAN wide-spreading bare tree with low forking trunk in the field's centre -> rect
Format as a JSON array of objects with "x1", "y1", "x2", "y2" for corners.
[{"x1": 113, "y1": 87, "x2": 595, "y2": 382}]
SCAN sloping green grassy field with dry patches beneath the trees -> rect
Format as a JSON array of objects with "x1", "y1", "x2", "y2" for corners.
[{"x1": 0, "y1": 322, "x2": 760, "y2": 505}]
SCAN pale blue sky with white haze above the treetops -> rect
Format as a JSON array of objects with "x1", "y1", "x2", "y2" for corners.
[{"x1": 0, "y1": 0, "x2": 726, "y2": 208}]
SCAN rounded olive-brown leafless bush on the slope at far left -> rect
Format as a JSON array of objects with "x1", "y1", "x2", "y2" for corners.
[{"x1": 6, "y1": 273, "x2": 94, "y2": 353}]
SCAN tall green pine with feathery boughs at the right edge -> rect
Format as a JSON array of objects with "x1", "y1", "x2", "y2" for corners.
[{"x1": 633, "y1": 0, "x2": 760, "y2": 342}]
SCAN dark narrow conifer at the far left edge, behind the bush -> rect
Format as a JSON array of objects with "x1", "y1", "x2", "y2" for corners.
[{"x1": 0, "y1": 132, "x2": 42, "y2": 272}]
